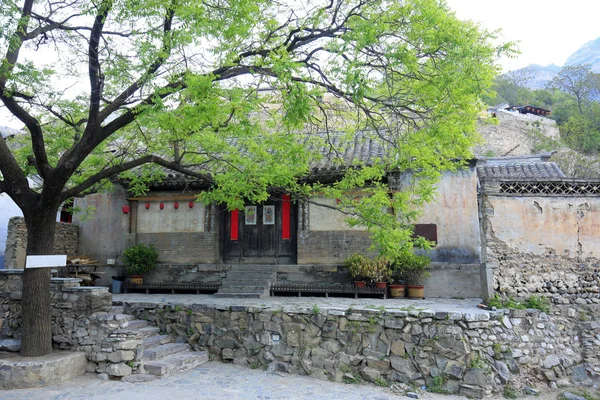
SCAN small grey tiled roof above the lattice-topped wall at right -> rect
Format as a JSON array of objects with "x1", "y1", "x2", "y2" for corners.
[{"x1": 477, "y1": 161, "x2": 566, "y2": 179}]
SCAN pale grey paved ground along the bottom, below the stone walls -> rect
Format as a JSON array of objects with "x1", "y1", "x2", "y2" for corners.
[{"x1": 0, "y1": 362, "x2": 560, "y2": 400}]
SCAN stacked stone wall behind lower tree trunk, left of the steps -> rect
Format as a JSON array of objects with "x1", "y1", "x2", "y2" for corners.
[{"x1": 0, "y1": 270, "x2": 149, "y2": 377}]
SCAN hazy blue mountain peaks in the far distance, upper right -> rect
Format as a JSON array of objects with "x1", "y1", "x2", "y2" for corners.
[{"x1": 511, "y1": 37, "x2": 600, "y2": 90}]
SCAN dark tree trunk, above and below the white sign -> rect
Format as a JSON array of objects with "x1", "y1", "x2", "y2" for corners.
[{"x1": 21, "y1": 207, "x2": 58, "y2": 357}]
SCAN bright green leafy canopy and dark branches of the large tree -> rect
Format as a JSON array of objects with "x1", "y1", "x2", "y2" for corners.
[{"x1": 0, "y1": 0, "x2": 504, "y2": 356}]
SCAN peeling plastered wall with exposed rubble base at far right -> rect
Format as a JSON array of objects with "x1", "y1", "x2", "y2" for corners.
[{"x1": 482, "y1": 189, "x2": 600, "y2": 305}]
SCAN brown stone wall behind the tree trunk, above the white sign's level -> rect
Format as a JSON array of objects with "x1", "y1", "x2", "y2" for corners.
[{"x1": 4, "y1": 217, "x2": 79, "y2": 269}]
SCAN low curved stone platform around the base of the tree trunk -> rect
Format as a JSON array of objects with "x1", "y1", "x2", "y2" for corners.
[{"x1": 0, "y1": 351, "x2": 87, "y2": 390}]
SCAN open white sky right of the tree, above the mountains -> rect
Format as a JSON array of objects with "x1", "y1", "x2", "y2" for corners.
[{"x1": 446, "y1": 0, "x2": 600, "y2": 72}]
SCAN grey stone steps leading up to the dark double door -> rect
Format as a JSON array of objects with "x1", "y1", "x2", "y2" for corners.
[{"x1": 215, "y1": 264, "x2": 277, "y2": 299}]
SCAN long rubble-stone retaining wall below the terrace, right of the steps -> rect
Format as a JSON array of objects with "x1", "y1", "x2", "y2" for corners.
[{"x1": 125, "y1": 303, "x2": 599, "y2": 397}]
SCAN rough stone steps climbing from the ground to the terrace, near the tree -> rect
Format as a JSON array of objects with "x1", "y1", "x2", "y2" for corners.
[{"x1": 111, "y1": 306, "x2": 208, "y2": 382}]
